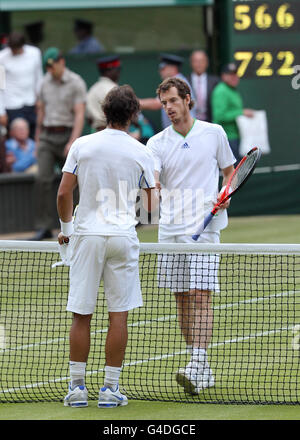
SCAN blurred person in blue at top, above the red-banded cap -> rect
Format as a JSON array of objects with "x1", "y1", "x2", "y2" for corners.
[{"x1": 70, "y1": 19, "x2": 105, "y2": 54}]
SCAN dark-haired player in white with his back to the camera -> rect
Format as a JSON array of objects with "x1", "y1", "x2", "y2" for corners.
[{"x1": 57, "y1": 86, "x2": 156, "y2": 408}]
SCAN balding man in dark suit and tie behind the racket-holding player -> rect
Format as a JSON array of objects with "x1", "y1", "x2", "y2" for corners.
[{"x1": 190, "y1": 50, "x2": 220, "y2": 122}]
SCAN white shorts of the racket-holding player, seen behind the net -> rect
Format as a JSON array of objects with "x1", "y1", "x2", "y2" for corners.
[{"x1": 157, "y1": 232, "x2": 220, "y2": 292}]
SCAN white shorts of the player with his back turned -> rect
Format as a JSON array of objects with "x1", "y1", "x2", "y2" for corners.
[{"x1": 67, "y1": 235, "x2": 143, "y2": 315}]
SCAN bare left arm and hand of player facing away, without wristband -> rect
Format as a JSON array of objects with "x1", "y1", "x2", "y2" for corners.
[{"x1": 57, "y1": 172, "x2": 77, "y2": 244}]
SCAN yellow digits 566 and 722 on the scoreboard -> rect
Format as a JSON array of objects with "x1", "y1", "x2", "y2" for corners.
[{"x1": 233, "y1": 1, "x2": 300, "y2": 78}]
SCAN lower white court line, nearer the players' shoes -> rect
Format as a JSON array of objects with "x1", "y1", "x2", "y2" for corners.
[{"x1": 0, "y1": 325, "x2": 295, "y2": 395}]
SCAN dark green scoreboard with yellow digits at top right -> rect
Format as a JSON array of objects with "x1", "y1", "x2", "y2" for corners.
[{"x1": 219, "y1": 0, "x2": 300, "y2": 166}]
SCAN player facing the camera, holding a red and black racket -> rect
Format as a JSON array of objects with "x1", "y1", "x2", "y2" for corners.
[{"x1": 147, "y1": 78, "x2": 235, "y2": 394}]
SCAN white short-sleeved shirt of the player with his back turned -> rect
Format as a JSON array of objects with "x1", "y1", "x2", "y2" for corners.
[{"x1": 63, "y1": 128, "x2": 155, "y2": 236}]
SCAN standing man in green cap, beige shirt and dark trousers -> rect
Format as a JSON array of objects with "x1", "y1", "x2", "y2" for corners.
[{"x1": 32, "y1": 47, "x2": 86, "y2": 240}]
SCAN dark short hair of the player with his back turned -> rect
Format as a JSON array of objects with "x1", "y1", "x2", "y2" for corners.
[{"x1": 103, "y1": 84, "x2": 140, "y2": 127}]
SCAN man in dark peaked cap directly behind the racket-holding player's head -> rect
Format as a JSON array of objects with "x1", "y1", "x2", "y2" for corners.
[{"x1": 140, "y1": 54, "x2": 196, "y2": 129}]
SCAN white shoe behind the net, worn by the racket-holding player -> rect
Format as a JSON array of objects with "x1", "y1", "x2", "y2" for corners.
[{"x1": 176, "y1": 362, "x2": 215, "y2": 394}]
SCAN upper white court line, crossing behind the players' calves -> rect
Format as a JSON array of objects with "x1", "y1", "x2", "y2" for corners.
[{"x1": 0, "y1": 290, "x2": 300, "y2": 354}]
